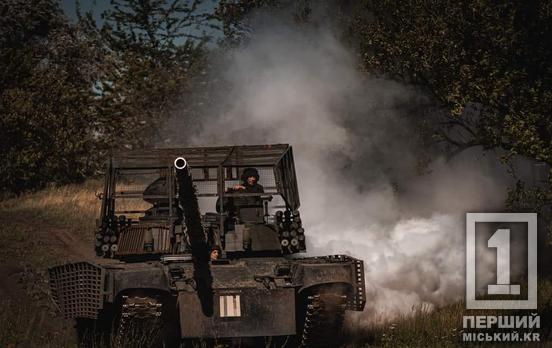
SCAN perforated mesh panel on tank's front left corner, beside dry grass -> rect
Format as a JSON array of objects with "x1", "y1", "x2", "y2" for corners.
[{"x1": 49, "y1": 262, "x2": 104, "y2": 319}]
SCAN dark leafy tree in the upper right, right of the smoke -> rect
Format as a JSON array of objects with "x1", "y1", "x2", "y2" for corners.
[{"x1": 349, "y1": 0, "x2": 552, "y2": 215}]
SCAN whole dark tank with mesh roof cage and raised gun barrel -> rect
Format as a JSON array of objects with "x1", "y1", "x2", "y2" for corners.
[{"x1": 49, "y1": 144, "x2": 365, "y2": 347}]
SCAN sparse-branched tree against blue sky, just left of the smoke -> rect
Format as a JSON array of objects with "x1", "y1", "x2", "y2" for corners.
[{"x1": 91, "y1": 0, "x2": 217, "y2": 149}]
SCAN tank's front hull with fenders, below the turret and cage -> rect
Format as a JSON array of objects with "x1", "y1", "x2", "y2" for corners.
[{"x1": 50, "y1": 255, "x2": 365, "y2": 338}]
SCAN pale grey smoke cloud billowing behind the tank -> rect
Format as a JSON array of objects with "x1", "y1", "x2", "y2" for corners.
[{"x1": 183, "y1": 20, "x2": 504, "y2": 318}]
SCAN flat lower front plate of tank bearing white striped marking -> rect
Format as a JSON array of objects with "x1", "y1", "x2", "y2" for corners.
[{"x1": 178, "y1": 288, "x2": 296, "y2": 338}]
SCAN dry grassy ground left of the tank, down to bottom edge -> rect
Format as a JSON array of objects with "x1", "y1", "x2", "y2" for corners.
[{"x1": 0, "y1": 181, "x2": 101, "y2": 347}]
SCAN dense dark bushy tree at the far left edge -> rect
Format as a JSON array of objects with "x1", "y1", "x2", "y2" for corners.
[{"x1": 0, "y1": 0, "x2": 104, "y2": 193}]
